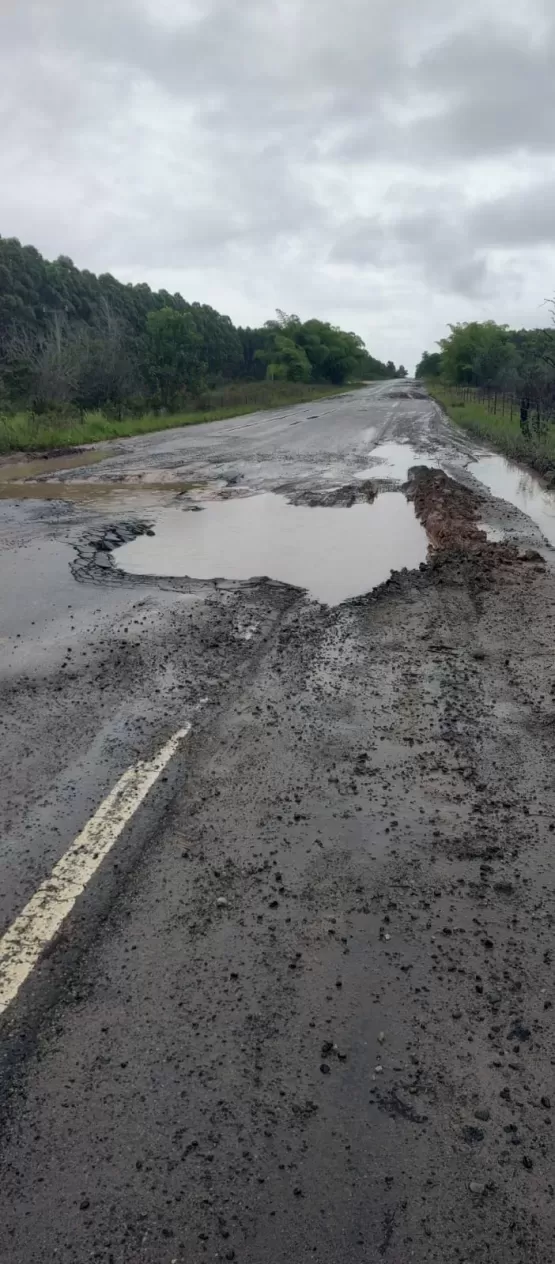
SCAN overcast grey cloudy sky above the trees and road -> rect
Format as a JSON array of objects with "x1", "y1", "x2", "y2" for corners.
[{"x1": 0, "y1": 0, "x2": 555, "y2": 370}]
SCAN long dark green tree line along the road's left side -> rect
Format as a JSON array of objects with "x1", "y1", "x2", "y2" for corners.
[{"x1": 0, "y1": 236, "x2": 406, "y2": 416}]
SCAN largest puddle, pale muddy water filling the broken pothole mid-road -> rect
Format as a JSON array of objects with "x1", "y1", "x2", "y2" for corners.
[{"x1": 113, "y1": 492, "x2": 427, "y2": 605}]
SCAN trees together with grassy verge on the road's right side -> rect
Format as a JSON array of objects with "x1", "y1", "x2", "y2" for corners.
[{"x1": 416, "y1": 321, "x2": 555, "y2": 483}]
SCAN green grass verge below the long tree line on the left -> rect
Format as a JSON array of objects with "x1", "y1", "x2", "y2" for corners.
[{"x1": 0, "y1": 382, "x2": 362, "y2": 454}]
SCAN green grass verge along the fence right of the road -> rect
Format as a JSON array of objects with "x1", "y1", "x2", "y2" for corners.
[{"x1": 426, "y1": 382, "x2": 555, "y2": 482}]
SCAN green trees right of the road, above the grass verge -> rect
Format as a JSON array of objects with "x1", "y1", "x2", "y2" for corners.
[{"x1": 416, "y1": 320, "x2": 555, "y2": 421}]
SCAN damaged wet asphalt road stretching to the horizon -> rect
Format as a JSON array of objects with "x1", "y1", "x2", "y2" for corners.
[{"x1": 0, "y1": 383, "x2": 555, "y2": 1264}]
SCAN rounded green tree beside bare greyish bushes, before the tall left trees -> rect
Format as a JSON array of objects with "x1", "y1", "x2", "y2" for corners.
[{"x1": 145, "y1": 307, "x2": 206, "y2": 408}]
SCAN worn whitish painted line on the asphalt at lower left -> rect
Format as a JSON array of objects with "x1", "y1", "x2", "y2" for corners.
[{"x1": 0, "y1": 724, "x2": 191, "y2": 1015}]
